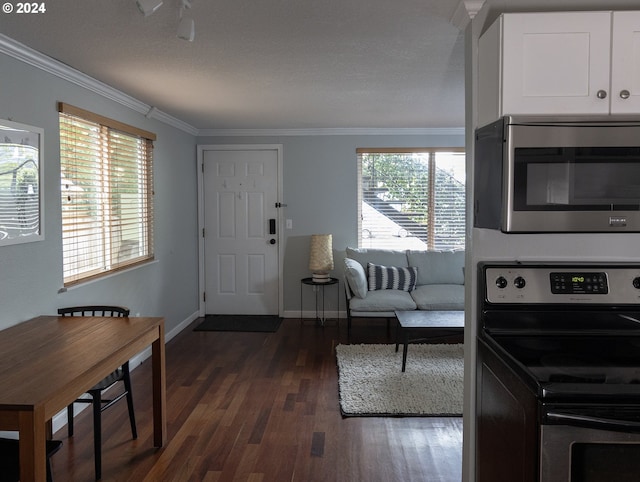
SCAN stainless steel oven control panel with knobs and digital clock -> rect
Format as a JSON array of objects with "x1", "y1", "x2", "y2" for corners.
[{"x1": 479, "y1": 263, "x2": 640, "y2": 304}]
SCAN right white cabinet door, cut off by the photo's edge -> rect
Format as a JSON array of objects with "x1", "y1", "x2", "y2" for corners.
[{"x1": 611, "y1": 12, "x2": 640, "y2": 114}]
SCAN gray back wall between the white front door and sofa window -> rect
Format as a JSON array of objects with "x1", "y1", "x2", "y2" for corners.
[{"x1": 198, "y1": 130, "x2": 464, "y2": 317}]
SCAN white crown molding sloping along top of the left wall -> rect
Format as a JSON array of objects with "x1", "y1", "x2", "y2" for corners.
[{"x1": 0, "y1": 34, "x2": 198, "y2": 136}]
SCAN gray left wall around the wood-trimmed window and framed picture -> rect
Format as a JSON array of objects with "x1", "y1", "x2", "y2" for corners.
[{"x1": 0, "y1": 54, "x2": 198, "y2": 334}]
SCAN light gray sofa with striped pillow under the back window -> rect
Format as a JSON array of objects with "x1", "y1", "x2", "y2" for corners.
[{"x1": 344, "y1": 248, "x2": 464, "y2": 335}]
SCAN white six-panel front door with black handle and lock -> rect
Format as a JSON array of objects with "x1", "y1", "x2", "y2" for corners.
[{"x1": 201, "y1": 146, "x2": 280, "y2": 315}]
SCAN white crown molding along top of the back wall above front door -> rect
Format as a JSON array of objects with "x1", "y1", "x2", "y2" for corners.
[{"x1": 198, "y1": 127, "x2": 464, "y2": 137}]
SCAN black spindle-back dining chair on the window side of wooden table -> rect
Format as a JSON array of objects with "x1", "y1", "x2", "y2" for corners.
[{"x1": 58, "y1": 306, "x2": 138, "y2": 480}]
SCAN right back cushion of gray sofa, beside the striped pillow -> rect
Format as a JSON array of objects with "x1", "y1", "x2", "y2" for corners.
[{"x1": 407, "y1": 250, "x2": 464, "y2": 286}]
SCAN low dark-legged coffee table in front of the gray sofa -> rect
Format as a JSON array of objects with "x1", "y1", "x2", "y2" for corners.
[{"x1": 395, "y1": 310, "x2": 464, "y2": 372}]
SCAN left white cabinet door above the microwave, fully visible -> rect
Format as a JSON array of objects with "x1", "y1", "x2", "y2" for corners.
[{"x1": 502, "y1": 12, "x2": 611, "y2": 114}]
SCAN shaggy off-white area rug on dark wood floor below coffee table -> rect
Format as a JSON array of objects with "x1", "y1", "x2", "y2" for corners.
[{"x1": 336, "y1": 344, "x2": 464, "y2": 416}]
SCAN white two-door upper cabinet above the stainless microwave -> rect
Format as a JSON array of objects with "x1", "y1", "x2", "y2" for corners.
[{"x1": 478, "y1": 11, "x2": 640, "y2": 125}]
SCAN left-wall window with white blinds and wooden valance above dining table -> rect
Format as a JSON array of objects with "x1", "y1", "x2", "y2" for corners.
[{"x1": 58, "y1": 103, "x2": 155, "y2": 286}]
